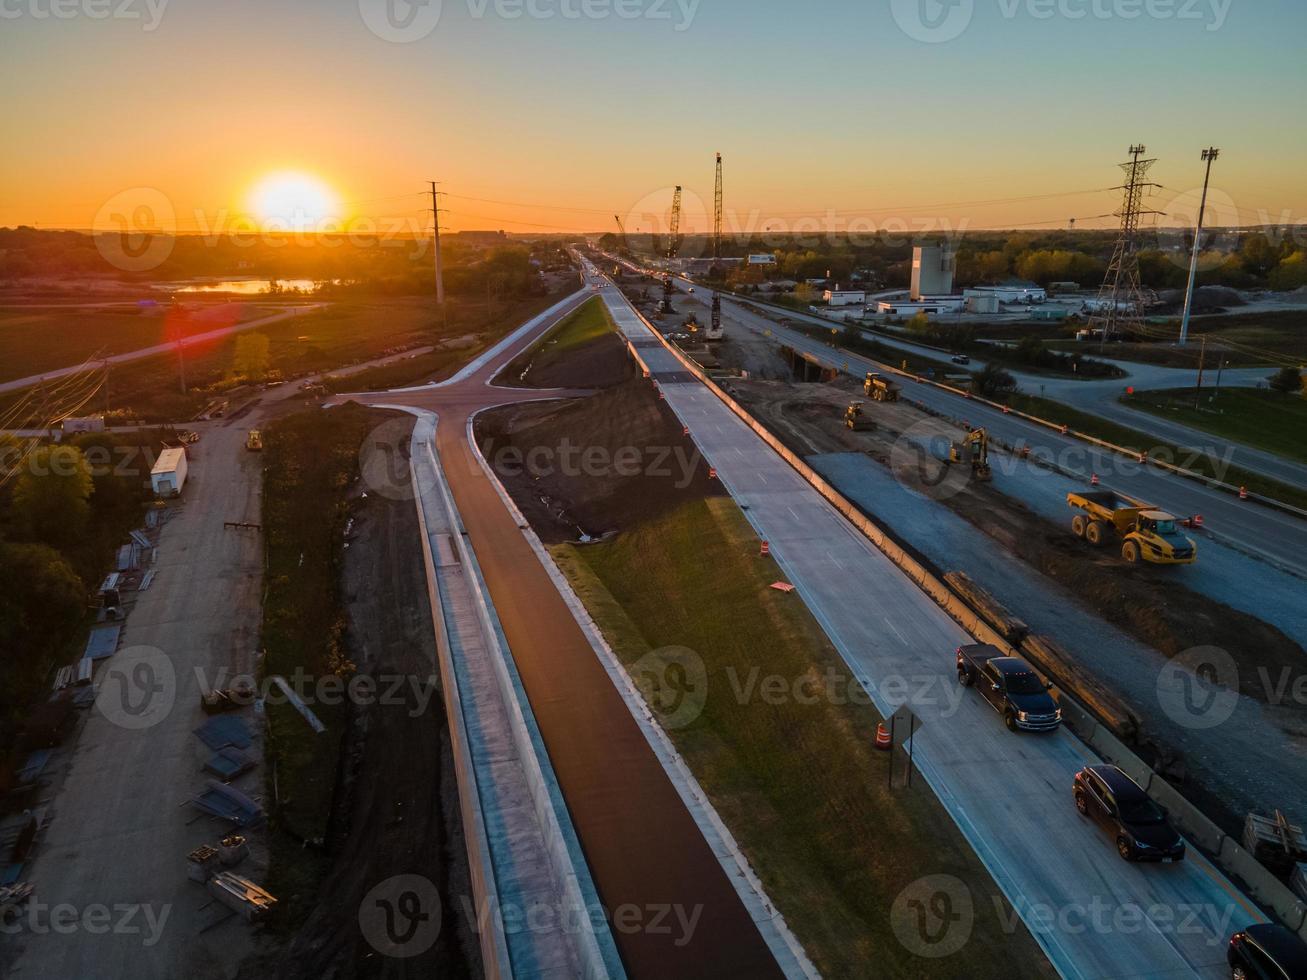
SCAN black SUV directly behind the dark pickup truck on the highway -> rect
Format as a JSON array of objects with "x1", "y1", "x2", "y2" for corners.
[{"x1": 1072, "y1": 766, "x2": 1184, "y2": 864}]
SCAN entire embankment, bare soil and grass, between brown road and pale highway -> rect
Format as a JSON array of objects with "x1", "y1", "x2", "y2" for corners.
[{"x1": 478, "y1": 314, "x2": 1046, "y2": 977}]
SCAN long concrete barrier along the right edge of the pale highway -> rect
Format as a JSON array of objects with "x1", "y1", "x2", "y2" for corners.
[{"x1": 616, "y1": 283, "x2": 1307, "y2": 939}]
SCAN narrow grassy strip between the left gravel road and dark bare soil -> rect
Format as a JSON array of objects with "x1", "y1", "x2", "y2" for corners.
[{"x1": 263, "y1": 405, "x2": 376, "y2": 924}]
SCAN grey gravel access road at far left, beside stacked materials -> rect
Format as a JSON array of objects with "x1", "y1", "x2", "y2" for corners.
[{"x1": 9, "y1": 422, "x2": 265, "y2": 980}]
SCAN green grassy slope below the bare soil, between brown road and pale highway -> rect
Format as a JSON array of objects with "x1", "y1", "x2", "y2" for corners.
[{"x1": 552, "y1": 498, "x2": 1047, "y2": 977}]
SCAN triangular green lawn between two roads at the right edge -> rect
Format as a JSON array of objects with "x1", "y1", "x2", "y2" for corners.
[{"x1": 1121, "y1": 388, "x2": 1307, "y2": 463}]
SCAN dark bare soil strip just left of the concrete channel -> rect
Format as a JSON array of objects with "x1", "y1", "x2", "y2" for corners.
[{"x1": 264, "y1": 423, "x2": 481, "y2": 980}]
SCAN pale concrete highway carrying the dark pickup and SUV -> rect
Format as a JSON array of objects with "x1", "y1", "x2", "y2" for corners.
[{"x1": 590, "y1": 262, "x2": 1263, "y2": 979}]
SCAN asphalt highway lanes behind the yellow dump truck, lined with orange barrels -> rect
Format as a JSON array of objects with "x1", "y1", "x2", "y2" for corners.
[{"x1": 700, "y1": 301, "x2": 1307, "y2": 575}]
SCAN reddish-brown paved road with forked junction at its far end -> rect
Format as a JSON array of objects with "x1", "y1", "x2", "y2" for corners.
[{"x1": 339, "y1": 299, "x2": 780, "y2": 979}]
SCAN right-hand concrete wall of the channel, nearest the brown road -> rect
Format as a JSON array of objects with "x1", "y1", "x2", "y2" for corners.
[{"x1": 426, "y1": 443, "x2": 623, "y2": 980}]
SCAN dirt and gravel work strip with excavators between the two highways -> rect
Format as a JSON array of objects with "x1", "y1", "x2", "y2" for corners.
[{"x1": 728, "y1": 380, "x2": 1307, "y2": 832}]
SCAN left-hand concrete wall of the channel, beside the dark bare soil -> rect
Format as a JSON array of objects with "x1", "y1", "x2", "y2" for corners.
[{"x1": 410, "y1": 436, "x2": 512, "y2": 980}]
